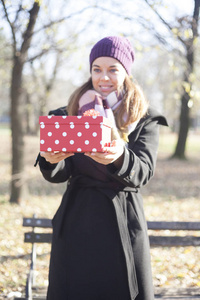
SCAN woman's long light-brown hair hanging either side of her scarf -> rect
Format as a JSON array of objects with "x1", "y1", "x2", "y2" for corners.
[{"x1": 67, "y1": 75, "x2": 148, "y2": 133}]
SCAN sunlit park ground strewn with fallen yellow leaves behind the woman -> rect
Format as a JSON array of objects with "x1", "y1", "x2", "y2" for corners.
[{"x1": 0, "y1": 129, "x2": 200, "y2": 299}]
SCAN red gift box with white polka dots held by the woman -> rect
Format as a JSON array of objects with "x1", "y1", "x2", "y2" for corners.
[{"x1": 39, "y1": 116, "x2": 111, "y2": 152}]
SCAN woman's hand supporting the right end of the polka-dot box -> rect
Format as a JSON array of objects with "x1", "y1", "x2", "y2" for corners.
[{"x1": 85, "y1": 140, "x2": 124, "y2": 168}]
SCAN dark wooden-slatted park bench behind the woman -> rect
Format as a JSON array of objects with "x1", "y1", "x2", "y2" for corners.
[{"x1": 15, "y1": 216, "x2": 200, "y2": 300}]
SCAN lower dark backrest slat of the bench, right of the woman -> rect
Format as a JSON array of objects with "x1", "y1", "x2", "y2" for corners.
[{"x1": 149, "y1": 235, "x2": 200, "y2": 247}]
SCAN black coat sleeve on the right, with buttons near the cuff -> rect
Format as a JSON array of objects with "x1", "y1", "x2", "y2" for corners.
[{"x1": 108, "y1": 119, "x2": 159, "y2": 188}]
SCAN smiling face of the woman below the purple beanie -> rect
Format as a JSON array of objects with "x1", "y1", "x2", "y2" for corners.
[{"x1": 91, "y1": 56, "x2": 126, "y2": 97}]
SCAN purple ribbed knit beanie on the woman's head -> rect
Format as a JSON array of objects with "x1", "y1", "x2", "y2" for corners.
[{"x1": 90, "y1": 36, "x2": 134, "y2": 75}]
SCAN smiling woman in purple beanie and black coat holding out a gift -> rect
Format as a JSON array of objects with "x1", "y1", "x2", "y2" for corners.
[{"x1": 39, "y1": 36, "x2": 167, "y2": 300}]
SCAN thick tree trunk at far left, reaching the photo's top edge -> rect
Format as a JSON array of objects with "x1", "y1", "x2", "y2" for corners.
[{"x1": 10, "y1": 1, "x2": 40, "y2": 204}]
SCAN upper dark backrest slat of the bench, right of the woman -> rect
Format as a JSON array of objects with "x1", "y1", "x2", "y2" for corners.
[{"x1": 147, "y1": 221, "x2": 200, "y2": 230}]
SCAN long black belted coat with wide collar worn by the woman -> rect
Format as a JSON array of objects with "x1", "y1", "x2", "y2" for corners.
[{"x1": 39, "y1": 108, "x2": 167, "y2": 300}]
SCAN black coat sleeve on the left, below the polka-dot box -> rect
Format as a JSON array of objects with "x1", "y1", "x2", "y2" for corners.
[{"x1": 39, "y1": 156, "x2": 71, "y2": 183}]
